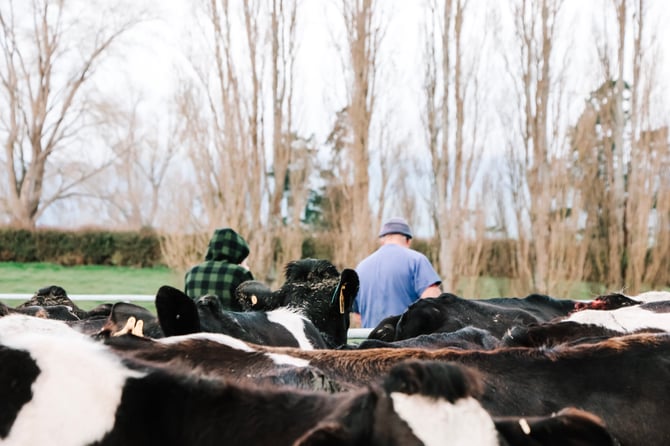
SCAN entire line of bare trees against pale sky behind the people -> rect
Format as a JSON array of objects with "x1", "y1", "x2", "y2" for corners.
[{"x1": 0, "y1": 0, "x2": 670, "y2": 297}]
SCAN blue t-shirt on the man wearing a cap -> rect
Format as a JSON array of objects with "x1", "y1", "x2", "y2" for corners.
[{"x1": 353, "y1": 244, "x2": 441, "y2": 328}]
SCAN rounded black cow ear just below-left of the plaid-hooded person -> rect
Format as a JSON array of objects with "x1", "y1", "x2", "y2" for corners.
[{"x1": 156, "y1": 285, "x2": 200, "y2": 336}]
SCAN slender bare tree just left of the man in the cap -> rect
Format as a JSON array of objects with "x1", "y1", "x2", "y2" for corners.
[{"x1": 330, "y1": 0, "x2": 384, "y2": 265}]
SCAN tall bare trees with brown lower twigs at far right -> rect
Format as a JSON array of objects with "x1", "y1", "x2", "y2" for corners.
[{"x1": 575, "y1": 0, "x2": 667, "y2": 291}]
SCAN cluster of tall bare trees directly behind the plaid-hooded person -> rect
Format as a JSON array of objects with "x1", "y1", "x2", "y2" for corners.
[{"x1": 173, "y1": 0, "x2": 309, "y2": 283}]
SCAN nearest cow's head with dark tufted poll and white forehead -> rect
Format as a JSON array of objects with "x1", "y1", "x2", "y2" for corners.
[{"x1": 294, "y1": 361, "x2": 498, "y2": 446}]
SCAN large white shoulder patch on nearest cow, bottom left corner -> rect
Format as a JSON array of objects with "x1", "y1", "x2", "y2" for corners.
[{"x1": 0, "y1": 316, "x2": 143, "y2": 446}]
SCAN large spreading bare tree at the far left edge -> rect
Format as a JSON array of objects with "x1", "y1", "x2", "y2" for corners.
[{"x1": 0, "y1": 0, "x2": 144, "y2": 228}]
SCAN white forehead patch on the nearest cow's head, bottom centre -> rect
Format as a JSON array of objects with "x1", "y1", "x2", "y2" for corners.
[{"x1": 391, "y1": 392, "x2": 498, "y2": 446}]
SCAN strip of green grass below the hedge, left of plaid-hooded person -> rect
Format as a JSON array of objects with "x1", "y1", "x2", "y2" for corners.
[{"x1": 0, "y1": 262, "x2": 184, "y2": 309}]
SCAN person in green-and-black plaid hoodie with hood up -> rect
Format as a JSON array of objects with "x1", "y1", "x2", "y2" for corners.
[{"x1": 184, "y1": 228, "x2": 254, "y2": 311}]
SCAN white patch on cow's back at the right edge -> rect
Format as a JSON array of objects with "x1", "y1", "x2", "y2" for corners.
[{"x1": 565, "y1": 305, "x2": 670, "y2": 332}]
